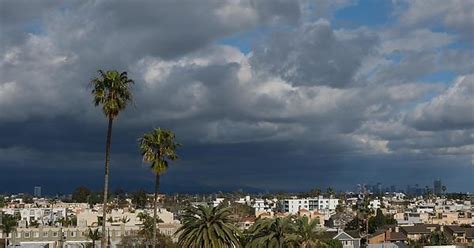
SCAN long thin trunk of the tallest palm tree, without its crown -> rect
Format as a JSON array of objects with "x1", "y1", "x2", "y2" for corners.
[{"x1": 101, "y1": 116, "x2": 113, "y2": 248}]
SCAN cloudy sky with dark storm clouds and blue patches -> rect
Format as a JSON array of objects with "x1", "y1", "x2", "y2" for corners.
[{"x1": 0, "y1": 0, "x2": 474, "y2": 194}]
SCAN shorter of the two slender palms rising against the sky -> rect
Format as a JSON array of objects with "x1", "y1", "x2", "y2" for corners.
[{"x1": 139, "y1": 128, "x2": 179, "y2": 248}]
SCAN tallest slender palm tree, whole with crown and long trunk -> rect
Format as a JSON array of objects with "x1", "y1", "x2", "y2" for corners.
[{"x1": 91, "y1": 70, "x2": 134, "y2": 247}]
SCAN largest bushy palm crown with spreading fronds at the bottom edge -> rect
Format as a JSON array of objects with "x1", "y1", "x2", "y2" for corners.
[{"x1": 175, "y1": 204, "x2": 240, "y2": 248}]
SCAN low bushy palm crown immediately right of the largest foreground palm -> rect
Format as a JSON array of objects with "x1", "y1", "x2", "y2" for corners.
[{"x1": 249, "y1": 217, "x2": 296, "y2": 248}]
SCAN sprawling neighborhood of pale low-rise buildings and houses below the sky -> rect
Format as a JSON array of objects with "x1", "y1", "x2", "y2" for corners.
[{"x1": 0, "y1": 179, "x2": 474, "y2": 248}]
